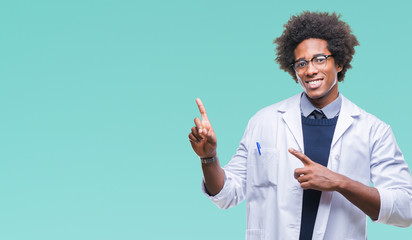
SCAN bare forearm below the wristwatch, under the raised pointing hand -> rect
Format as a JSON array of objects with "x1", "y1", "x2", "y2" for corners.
[{"x1": 202, "y1": 159, "x2": 225, "y2": 196}]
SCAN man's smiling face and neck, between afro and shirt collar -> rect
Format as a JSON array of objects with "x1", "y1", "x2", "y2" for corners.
[{"x1": 294, "y1": 38, "x2": 342, "y2": 108}]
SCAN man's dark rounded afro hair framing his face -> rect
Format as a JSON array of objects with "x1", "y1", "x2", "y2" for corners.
[{"x1": 274, "y1": 11, "x2": 359, "y2": 82}]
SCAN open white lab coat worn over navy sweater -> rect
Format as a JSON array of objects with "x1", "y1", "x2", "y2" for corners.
[{"x1": 202, "y1": 94, "x2": 412, "y2": 240}]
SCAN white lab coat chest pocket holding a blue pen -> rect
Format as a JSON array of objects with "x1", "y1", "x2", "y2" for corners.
[{"x1": 249, "y1": 148, "x2": 279, "y2": 187}]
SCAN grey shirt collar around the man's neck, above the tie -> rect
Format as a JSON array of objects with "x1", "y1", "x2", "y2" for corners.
[{"x1": 300, "y1": 92, "x2": 342, "y2": 119}]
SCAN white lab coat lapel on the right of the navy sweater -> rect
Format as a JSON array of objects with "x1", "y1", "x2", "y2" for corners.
[{"x1": 331, "y1": 95, "x2": 359, "y2": 149}]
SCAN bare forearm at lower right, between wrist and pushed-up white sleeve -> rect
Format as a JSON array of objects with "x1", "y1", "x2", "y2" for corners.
[{"x1": 337, "y1": 176, "x2": 381, "y2": 220}]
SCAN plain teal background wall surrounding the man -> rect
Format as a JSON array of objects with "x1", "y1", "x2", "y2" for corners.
[{"x1": 0, "y1": 0, "x2": 412, "y2": 240}]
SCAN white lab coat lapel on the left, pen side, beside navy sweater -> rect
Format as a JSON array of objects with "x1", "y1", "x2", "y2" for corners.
[{"x1": 278, "y1": 94, "x2": 304, "y2": 152}]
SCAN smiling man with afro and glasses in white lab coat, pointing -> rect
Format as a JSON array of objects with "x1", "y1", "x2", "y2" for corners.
[{"x1": 189, "y1": 12, "x2": 412, "y2": 240}]
